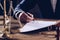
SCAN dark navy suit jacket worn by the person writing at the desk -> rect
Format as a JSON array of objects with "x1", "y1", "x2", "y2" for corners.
[{"x1": 14, "y1": 0, "x2": 60, "y2": 19}]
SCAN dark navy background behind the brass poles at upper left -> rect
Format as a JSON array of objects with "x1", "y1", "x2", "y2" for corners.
[{"x1": 0, "y1": 0, "x2": 21, "y2": 15}]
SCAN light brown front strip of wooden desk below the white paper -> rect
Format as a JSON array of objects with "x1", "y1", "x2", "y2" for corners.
[{"x1": 8, "y1": 32, "x2": 56, "y2": 40}]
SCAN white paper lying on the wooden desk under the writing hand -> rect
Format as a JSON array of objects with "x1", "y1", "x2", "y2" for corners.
[{"x1": 19, "y1": 20, "x2": 56, "y2": 32}]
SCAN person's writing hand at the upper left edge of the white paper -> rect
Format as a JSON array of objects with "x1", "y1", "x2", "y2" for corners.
[{"x1": 20, "y1": 12, "x2": 34, "y2": 22}]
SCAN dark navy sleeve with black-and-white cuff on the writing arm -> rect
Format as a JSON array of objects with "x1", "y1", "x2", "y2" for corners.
[{"x1": 14, "y1": 0, "x2": 37, "y2": 19}]
